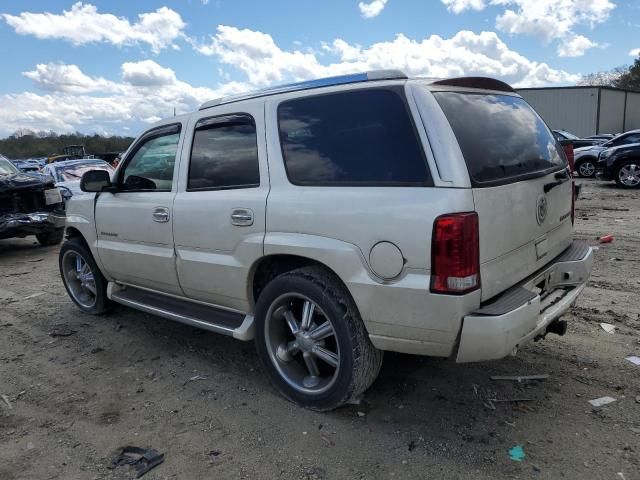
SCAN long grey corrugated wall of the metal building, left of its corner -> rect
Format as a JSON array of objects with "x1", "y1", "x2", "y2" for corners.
[{"x1": 518, "y1": 87, "x2": 598, "y2": 137}]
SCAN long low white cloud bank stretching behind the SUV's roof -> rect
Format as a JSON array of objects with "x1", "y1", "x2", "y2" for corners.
[{"x1": 0, "y1": 25, "x2": 578, "y2": 134}]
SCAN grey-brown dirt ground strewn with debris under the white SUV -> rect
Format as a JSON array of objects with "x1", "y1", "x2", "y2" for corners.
[{"x1": 0, "y1": 181, "x2": 640, "y2": 480}]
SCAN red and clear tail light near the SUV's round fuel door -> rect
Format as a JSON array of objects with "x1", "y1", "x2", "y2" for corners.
[{"x1": 431, "y1": 212, "x2": 480, "y2": 295}]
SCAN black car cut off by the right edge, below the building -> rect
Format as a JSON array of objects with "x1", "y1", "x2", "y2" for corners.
[{"x1": 597, "y1": 143, "x2": 640, "y2": 188}]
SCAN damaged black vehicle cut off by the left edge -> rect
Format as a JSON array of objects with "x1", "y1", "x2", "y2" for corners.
[{"x1": 0, "y1": 158, "x2": 65, "y2": 245}]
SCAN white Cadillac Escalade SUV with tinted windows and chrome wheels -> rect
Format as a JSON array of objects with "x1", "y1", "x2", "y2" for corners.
[{"x1": 60, "y1": 71, "x2": 593, "y2": 410}]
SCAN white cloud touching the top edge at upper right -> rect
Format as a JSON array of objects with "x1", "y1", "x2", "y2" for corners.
[{"x1": 441, "y1": 0, "x2": 615, "y2": 56}]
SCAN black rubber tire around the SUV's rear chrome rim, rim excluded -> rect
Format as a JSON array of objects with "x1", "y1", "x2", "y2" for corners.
[{"x1": 256, "y1": 267, "x2": 383, "y2": 411}]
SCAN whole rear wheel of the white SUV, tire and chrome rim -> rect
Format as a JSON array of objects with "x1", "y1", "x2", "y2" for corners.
[{"x1": 256, "y1": 267, "x2": 383, "y2": 411}]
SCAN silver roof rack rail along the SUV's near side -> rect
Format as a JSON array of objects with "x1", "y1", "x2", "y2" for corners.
[{"x1": 199, "y1": 70, "x2": 408, "y2": 110}]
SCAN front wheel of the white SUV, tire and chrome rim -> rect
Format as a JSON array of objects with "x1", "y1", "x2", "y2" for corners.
[{"x1": 58, "y1": 238, "x2": 110, "y2": 315}]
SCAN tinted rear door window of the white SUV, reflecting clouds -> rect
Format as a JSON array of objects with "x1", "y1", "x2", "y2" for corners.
[{"x1": 187, "y1": 116, "x2": 260, "y2": 191}]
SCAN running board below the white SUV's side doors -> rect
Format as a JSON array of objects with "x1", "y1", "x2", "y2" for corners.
[{"x1": 107, "y1": 282, "x2": 253, "y2": 341}]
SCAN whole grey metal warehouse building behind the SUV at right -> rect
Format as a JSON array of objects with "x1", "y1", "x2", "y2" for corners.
[{"x1": 518, "y1": 87, "x2": 640, "y2": 137}]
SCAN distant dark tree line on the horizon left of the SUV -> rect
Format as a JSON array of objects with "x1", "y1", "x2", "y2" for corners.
[{"x1": 0, "y1": 129, "x2": 134, "y2": 160}]
